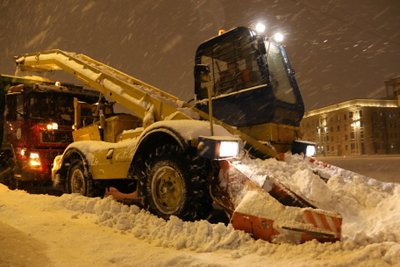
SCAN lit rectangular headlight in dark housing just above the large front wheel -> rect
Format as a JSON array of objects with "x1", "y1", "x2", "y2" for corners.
[{"x1": 197, "y1": 136, "x2": 240, "y2": 160}]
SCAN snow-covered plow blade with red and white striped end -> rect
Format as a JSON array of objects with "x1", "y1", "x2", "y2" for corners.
[{"x1": 211, "y1": 161, "x2": 342, "y2": 243}]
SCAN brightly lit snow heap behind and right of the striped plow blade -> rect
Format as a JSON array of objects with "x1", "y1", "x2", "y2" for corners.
[{"x1": 236, "y1": 154, "x2": 400, "y2": 246}]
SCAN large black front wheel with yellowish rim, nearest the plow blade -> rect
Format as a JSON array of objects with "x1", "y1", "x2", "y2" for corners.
[{"x1": 141, "y1": 145, "x2": 212, "y2": 220}]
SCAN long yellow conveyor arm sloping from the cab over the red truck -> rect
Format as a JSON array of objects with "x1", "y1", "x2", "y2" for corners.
[{"x1": 16, "y1": 49, "x2": 278, "y2": 157}]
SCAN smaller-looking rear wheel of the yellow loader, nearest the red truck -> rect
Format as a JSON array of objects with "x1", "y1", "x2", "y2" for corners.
[{"x1": 66, "y1": 160, "x2": 96, "y2": 197}]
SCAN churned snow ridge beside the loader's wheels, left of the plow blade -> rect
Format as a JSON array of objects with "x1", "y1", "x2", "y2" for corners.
[{"x1": 60, "y1": 195, "x2": 252, "y2": 252}]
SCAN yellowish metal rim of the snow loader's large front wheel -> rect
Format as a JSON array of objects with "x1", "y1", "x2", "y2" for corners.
[{"x1": 151, "y1": 166, "x2": 185, "y2": 214}]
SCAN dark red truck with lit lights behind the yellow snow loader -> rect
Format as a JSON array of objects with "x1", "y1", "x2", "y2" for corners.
[{"x1": 0, "y1": 75, "x2": 99, "y2": 189}]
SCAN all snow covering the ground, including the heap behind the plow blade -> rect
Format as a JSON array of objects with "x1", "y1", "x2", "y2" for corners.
[{"x1": 0, "y1": 157, "x2": 400, "y2": 267}]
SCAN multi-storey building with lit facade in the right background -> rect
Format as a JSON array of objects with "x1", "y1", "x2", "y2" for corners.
[{"x1": 301, "y1": 77, "x2": 400, "y2": 156}]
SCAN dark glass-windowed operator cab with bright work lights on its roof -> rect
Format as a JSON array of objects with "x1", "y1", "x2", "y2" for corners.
[{"x1": 195, "y1": 27, "x2": 304, "y2": 127}]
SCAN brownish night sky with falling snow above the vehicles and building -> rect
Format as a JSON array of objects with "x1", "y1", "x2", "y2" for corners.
[{"x1": 0, "y1": 0, "x2": 400, "y2": 110}]
